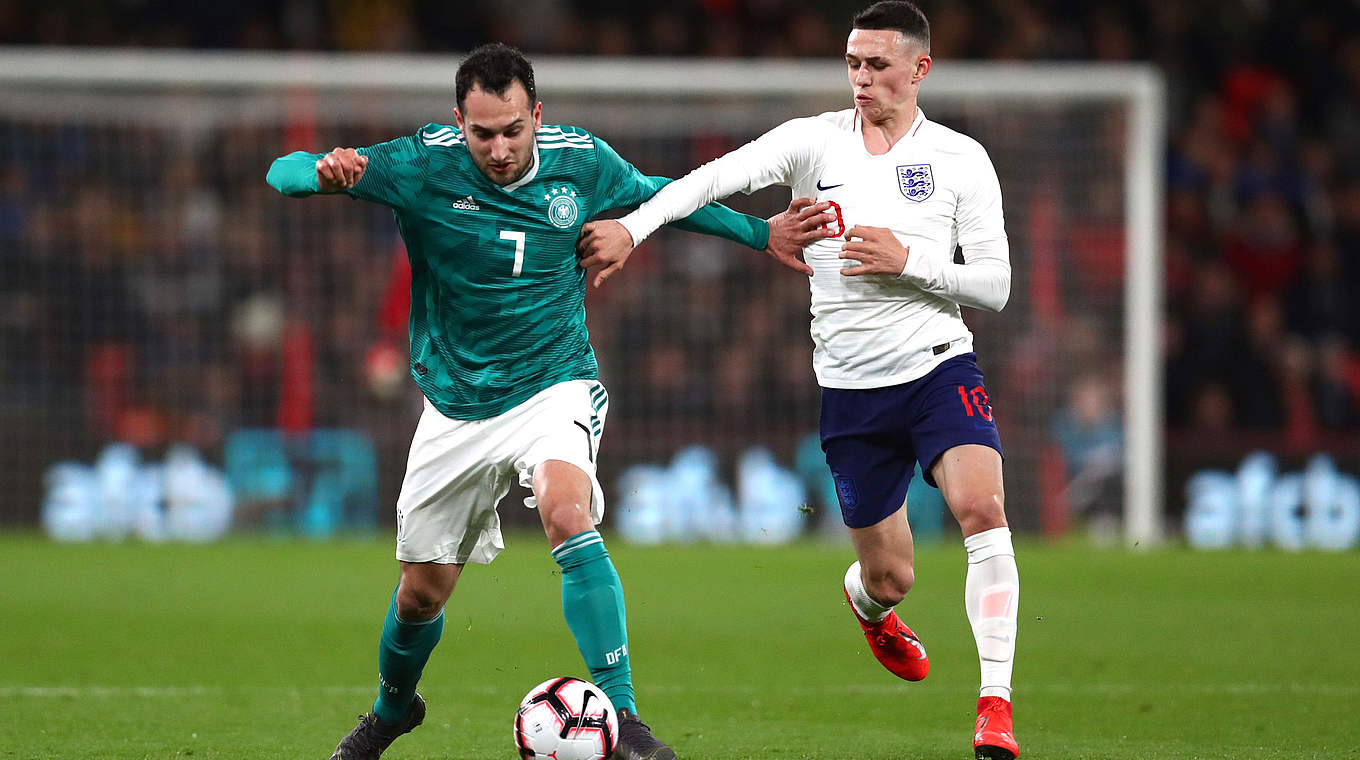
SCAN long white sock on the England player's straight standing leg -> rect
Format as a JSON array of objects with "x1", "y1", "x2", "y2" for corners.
[{"x1": 963, "y1": 528, "x2": 1020, "y2": 700}]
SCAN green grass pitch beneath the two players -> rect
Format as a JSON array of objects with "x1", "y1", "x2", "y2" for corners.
[{"x1": 0, "y1": 534, "x2": 1360, "y2": 760}]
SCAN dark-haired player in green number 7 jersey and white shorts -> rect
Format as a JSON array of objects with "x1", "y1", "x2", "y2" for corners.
[{"x1": 268, "y1": 45, "x2": 817, "y2": 760}]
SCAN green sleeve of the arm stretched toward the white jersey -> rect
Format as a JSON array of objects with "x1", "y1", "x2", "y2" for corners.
[{"x1": 594, "y1": 137, "x2": 770, "y2": 250}]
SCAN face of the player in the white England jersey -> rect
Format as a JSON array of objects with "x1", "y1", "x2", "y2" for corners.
[{"x1": 846, "y1": 29, "x2": 930, "y2": 124}]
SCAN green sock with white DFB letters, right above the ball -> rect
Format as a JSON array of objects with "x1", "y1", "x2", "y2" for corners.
[{"x1": 552, "y1": 530, "x2": 638, "y2": 714}]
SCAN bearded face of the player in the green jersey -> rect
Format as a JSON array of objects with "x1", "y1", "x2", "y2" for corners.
[{"x1": 453, "y1": 82, "x2": 543, "y2": 186}]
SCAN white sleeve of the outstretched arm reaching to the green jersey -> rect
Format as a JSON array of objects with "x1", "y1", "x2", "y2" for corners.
[{"x1": 619, "y1": 118, "x2": 811, "y2": 245}]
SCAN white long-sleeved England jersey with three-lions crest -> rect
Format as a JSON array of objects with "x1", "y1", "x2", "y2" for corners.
[{"x1": 620, "y1": 109, "x2": 1010, "y2": 387}]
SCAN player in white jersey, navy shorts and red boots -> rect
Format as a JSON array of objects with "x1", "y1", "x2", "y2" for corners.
[{"x1": 578, "y1": 1, "x2": 1020, "y2": 760}]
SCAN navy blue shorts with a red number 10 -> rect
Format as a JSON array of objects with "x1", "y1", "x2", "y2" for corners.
[{"x1": 821, "y1": 353, "x2": 1001, "y2": 528}]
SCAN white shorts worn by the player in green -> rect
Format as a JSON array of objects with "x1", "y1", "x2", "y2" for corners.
[{"x1": 397, "y1": 379, "x2": 609, "y2": 564}]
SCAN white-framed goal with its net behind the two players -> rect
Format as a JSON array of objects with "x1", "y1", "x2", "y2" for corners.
[{"x1": 0, "y1": 50, "x2": 1163, "y2": 541}]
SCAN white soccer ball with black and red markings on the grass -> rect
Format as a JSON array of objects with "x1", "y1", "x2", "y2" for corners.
[{"x1": 514, "y1": 677, "x2": 619, "y2": 760}]
